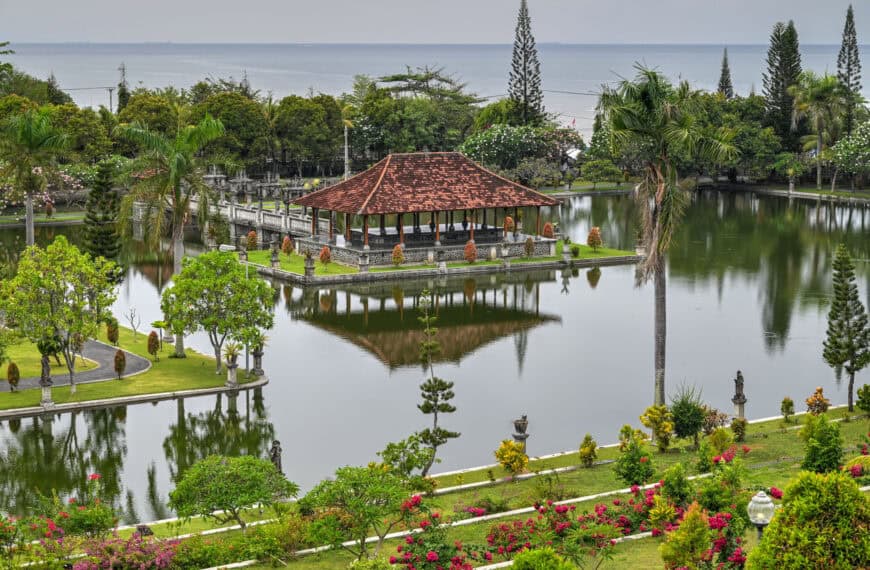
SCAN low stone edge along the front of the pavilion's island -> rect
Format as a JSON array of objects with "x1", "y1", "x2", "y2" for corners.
[{"x1": 242, "y1": 255, "x2": 643, "y2": 285}]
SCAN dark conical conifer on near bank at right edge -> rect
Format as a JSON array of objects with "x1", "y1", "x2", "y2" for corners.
[{"x1": 822, "y1": 244, "x2": 870, "y2": 412}]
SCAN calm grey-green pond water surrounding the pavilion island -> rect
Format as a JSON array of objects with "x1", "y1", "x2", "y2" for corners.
[{"x1": 0, "y1": 193, "x2": 870, "y2": 520}]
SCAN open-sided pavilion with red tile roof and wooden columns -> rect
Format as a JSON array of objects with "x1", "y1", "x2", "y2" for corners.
[{"x1": 295, "y1": 152, "x2": 558, "y2": 251}]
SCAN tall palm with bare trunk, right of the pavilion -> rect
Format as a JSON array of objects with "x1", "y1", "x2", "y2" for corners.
[{"x1": 598, "y1": 65, "x2": 736, "y2": 405}]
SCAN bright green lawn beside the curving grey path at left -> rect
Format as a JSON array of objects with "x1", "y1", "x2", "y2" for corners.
[{"x1": 0, "y1": 327, "x2": 252, "y2": 410}]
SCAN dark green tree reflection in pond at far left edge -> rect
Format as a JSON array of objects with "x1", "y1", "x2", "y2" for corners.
[{"x1": 0, "y1": 407, "x2": 127, "y2": 514}]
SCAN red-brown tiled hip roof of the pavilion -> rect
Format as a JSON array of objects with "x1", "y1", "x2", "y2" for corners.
[{"x1": 295, "y1": 152, "x2": 558, "y2": 215}]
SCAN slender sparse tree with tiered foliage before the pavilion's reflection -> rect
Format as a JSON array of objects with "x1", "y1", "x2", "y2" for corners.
[{"x1": 417, "y1": 291, "x2": 460, "y2": 477}]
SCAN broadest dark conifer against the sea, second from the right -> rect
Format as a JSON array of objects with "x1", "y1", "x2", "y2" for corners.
[{"x1": 763, "y1": 21, "x2": 806, "y2": 150}]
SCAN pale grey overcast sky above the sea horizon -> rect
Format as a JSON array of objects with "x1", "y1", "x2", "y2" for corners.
[{"x1": 0, "y1": 0, "x2": 870, "y2": 44}]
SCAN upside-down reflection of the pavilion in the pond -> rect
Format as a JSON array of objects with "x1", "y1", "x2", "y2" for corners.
[{"x1": 285, "y1": 271, "x2": 562, "y2": 369}]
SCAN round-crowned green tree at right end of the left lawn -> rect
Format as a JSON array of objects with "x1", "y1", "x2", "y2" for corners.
[{"x1": 160, "y1": 251, "x2": 274, "y2": 374}]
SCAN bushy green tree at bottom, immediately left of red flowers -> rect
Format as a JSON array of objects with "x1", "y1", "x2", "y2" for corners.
[{"x1": 300, "y1": 466, "x2": 413, "y2": 559}]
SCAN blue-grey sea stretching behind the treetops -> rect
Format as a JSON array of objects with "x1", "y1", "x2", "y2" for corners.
[{"x1": 8, "y1": 43, "x2": 870, "y2": 139}]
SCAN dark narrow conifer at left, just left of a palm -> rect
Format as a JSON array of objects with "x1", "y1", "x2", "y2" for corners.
[{"x1": 83, "y1": 161, "x2": 121, "y2": 259}]
